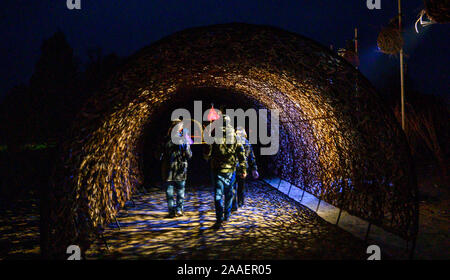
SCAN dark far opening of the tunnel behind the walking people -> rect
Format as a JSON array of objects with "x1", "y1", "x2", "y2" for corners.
[{"x1": 140, "y1": 87, "x2": 274, "y2": 186}]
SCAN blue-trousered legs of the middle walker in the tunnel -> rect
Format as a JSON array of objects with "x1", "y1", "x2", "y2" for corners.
[{"x1": 211, "y1": 172, "x2": 235, "y2": 223}]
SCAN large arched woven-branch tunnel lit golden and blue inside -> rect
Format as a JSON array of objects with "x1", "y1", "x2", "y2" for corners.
[{"x1": 48, "y1": 24, "x2": 418, "y2": 258}]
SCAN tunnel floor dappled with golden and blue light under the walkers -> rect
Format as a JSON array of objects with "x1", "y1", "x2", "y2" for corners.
[{"x1": 87, "y1": 182, "x2": 367, "y2": 260}]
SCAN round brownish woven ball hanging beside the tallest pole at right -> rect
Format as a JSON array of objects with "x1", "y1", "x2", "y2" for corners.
[{"x1": 377, "y1": 17, "x2": 403, "y2": 55}]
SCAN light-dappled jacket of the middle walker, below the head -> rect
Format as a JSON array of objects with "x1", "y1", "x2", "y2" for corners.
[{"x1": 204, "y1": 126, "x2": 247, "y2": 173}]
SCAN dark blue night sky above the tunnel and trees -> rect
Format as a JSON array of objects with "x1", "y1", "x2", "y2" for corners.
[{"x1": 0, "y1": 0, "x2": 450, "y2": 97}]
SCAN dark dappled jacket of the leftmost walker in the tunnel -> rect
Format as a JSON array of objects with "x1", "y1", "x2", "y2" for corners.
[{"x1": 161, "y1": 137, "x2": 192, "y2": 181}]
